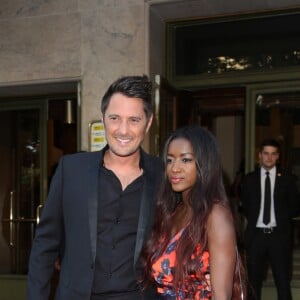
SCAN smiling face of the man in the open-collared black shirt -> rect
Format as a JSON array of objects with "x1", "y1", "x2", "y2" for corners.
[{"x1": 103, "y1": 93, "x2": 152, "y2": 157}]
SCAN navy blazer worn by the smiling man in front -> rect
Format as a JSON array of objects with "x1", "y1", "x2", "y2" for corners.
[{"x1": 27, "y1": 150, "x2": 162, "y2": 300}]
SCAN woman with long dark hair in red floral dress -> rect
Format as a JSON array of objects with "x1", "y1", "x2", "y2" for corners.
[{"x1": 143, "y1": 127, "x2": 245, "y2": 300}]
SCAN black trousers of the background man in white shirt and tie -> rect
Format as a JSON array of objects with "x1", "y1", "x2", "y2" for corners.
[{"x1": 246, "y1": 228, "x2": 292, "y2": 300}]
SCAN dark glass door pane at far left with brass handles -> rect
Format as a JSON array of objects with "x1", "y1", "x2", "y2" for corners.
[{"x1": 0, "y1": 102, "x2": 43, "y2": 274}]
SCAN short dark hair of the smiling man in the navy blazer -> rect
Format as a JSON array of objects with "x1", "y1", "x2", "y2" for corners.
[{"x1": 101, "y1": 75, "x2": 153, "y2": 119}]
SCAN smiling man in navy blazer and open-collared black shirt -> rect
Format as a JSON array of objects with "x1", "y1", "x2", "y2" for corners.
[{"x1": 27, "y1": 76, "x2": 162, "y2": 300}]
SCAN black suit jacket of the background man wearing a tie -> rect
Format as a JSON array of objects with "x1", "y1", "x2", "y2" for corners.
[{"x1": 241, "y1": 168, "x2": 300, "y2": 246}]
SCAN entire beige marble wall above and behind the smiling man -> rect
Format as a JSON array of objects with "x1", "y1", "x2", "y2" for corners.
[{"x1": 0, "y1": 0, "x2": 300, "y2": 150}]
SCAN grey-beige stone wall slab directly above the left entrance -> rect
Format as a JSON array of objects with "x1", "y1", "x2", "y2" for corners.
[{"x1": 0, "y1": 0, "x2": 81, "y2": 85}]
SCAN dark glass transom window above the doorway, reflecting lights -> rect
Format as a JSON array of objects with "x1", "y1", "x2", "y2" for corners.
[{"x1": 169, "y1": 13, "x2": 300, "y2": 76}]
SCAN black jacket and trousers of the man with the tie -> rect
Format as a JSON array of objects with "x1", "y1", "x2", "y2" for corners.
[{"x1": 241, "y1": 169, "x2": 300, "y2": 300}]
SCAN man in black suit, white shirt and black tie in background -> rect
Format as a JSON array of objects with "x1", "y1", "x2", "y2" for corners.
[{"x1": 241, "y1": 139, "x2": 300, "y2": 300}]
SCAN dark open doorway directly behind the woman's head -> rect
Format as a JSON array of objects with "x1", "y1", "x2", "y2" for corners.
[{"x1": 150, "y1": 75, "x2": 246, "y2": 205}]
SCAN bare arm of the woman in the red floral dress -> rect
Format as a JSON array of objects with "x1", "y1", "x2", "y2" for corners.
[{"x1": 207, "y1": 204, "x2": 236, "y2": 300}]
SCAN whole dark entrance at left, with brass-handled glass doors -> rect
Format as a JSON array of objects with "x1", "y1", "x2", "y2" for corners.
[{"x1": 0, "y1": 95, "x2": 77, "y2": 300}]
